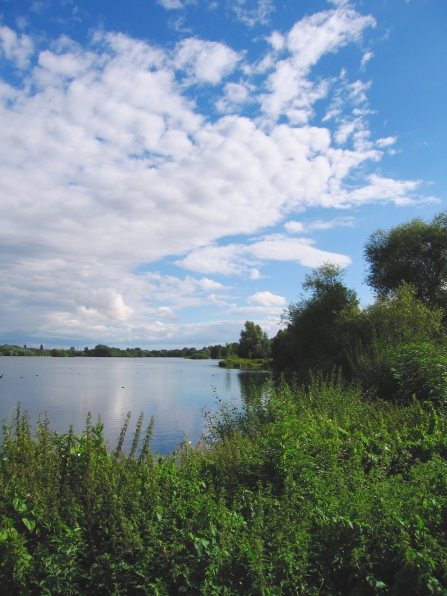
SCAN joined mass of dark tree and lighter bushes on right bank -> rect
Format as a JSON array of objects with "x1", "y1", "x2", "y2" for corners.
[{"x1": 272, "y1": 265, "x2": 447, "y2": 402}]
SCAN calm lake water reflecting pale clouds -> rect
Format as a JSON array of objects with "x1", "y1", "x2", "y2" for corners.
[{"x1": 0, "y1": 356, "x2": 268, "y2": 454}]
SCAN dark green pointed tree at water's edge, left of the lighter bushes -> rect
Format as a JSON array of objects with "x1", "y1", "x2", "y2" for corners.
[{"x1": 272, "y1": 263, "x2": 359, "y2": 383}]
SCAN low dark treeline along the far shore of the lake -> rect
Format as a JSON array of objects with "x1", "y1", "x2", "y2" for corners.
[{"x1": 0, "y1": 344, "x2": 231, "y2": 360}]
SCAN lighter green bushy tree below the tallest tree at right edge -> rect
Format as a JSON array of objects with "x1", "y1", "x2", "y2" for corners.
[{"x1": 346, "y1": 283, "x2": 446, "y2": 400}]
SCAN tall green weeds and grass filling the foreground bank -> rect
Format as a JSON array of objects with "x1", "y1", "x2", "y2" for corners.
[{"x1": 0, "y1": 377, "x2": 447, "y2": 596}]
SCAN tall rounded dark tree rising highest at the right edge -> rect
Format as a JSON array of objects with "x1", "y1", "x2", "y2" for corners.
[{"x1": 364, "y1": 212, "x2": 447, "y2": 309}]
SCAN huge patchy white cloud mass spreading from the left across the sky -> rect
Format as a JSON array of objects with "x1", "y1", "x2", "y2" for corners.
[{"x1": 0, "y1": 2, "x2": 430, "y2": 340}]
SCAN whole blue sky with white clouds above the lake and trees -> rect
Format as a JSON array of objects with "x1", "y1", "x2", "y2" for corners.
[{"x1": 0, "y1": 0, "x2": 447, "y2": 349}]
